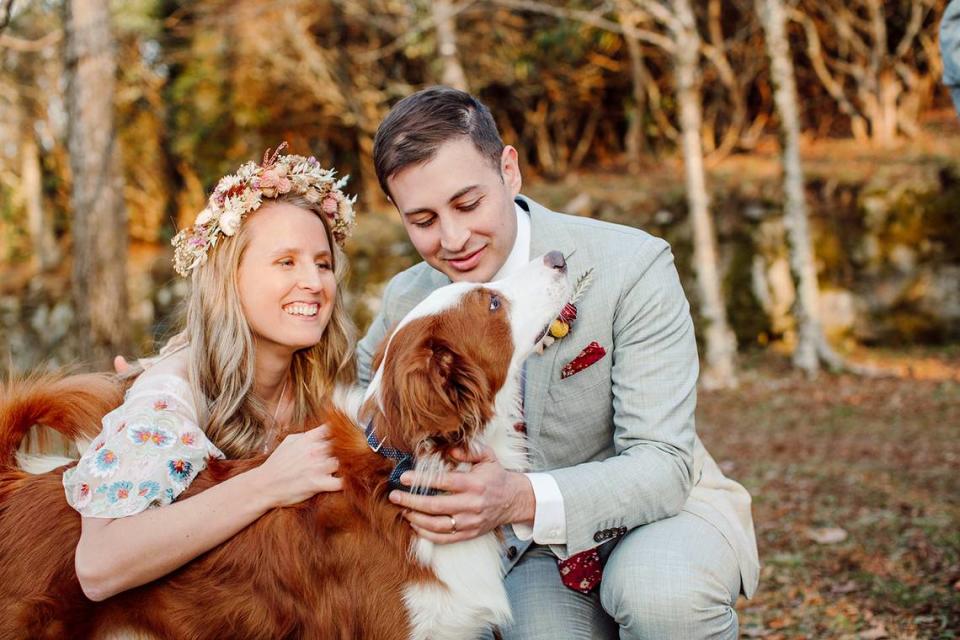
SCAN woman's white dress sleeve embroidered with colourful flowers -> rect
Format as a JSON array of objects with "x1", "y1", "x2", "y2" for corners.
[{"x1": 63, "y1": 371, "x2": 224, "y2": 518}]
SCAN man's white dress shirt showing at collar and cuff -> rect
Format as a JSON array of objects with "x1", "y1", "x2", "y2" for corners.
[{"x1": 493, "y1": 204, "x2": 567, "y2": 544}]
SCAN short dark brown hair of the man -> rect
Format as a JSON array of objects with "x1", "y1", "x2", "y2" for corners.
[{"x1": 373, "y1": 87, "x2": 503, "y2": 196}]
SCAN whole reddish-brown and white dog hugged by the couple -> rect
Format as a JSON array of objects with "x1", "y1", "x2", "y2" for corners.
[{"x1": 0, "y1": 252, "x2": 569, "y2": 640}]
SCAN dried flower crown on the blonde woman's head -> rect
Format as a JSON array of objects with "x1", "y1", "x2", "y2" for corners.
[{"x1": 172, "y1": 142, "x2": 357, "y2": 277}]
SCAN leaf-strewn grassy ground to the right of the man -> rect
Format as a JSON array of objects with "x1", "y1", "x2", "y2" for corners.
[{"x1": 698, "y1": 348, "x2": 960, "y2": 640}]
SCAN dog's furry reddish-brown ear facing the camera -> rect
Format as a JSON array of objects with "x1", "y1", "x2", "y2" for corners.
[{"x1": 381, "y1": 327, "x2": 493, "y2": 448}]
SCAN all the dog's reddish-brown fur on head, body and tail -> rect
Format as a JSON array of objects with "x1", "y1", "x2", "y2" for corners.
[{"x1": 0, "y1": 288, "x2": 510, "y2": 640}]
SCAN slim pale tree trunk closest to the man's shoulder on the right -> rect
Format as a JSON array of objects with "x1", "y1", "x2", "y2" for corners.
[{"x1": 673, "y1": 0, "x2": 737, "y2": 389}]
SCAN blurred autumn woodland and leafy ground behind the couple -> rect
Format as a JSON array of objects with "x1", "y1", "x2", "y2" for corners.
[{"x1": 0, "y1": 0, "x2": 960, "y2": 638}]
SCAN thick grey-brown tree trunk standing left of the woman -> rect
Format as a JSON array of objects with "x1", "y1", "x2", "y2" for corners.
[{"x1": 65, "y1": 0, "x2": 128, "y2": 367}]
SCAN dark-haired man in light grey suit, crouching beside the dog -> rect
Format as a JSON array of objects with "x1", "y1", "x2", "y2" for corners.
[{"x1": 358, "y1": 87, "x2": 759, "y2": 640}]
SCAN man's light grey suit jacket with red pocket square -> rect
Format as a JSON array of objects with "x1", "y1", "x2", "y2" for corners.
[{"x1": 357, "y1": 196, "x2": 759, "y2": 596}]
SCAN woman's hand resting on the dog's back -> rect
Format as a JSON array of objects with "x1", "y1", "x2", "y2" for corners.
[{"x1": 254, "y1": 425, "x2": 343, "y2": 507}]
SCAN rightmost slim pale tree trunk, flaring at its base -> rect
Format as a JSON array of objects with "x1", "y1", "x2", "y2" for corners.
[{"x1": 756, "y1": 0, "x2": 839, "y2": 376}]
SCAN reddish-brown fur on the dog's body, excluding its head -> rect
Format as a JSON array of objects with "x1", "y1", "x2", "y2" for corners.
[{"x1": 0, "y1": 379, "x2": 430, "y2": 639}]
